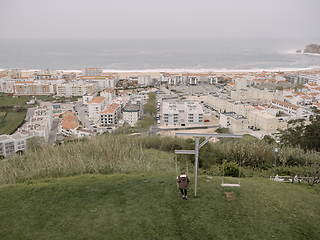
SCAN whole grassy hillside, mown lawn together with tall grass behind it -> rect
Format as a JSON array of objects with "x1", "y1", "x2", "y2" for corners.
[{"x1": 0, "y1": 135, "x2": 320, "y2": 239}]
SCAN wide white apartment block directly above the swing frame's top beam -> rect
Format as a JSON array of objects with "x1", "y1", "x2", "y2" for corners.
[{"x1": 161, "y1": 101, "x2": 204, "y2": 127}]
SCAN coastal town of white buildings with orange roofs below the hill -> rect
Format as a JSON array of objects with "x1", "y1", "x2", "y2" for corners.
[{"x1": 0, "y1": 68, "x2": 320, "y2": 157}]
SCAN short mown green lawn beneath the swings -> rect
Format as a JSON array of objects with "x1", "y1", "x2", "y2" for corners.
[{"x1": 0, "y1": 174, "x2": 320, "y2": 239}]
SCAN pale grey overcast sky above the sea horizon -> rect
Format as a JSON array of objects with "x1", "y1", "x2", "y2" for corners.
[{"x1": 0, "y1": 0, "x2": 320, "y2": 39}]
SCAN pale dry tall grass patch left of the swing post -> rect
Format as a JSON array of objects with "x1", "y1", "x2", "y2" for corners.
[{"x1": 0, "y1": 135, "x2": 174, "y2": 183}]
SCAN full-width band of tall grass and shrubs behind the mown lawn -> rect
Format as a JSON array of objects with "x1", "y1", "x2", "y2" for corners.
[{"x1": 0, "y1": 135, "x2": 320, "y2": 184}]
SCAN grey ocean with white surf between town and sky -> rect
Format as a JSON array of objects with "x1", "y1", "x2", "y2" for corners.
[{"x1": 0, "y1": 38, "x2": 320, "y2": 72}]
